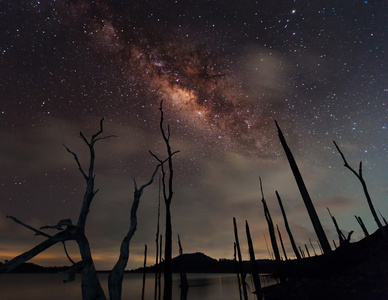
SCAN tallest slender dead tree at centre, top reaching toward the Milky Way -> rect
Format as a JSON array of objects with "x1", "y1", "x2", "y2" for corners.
[{"x1": 150, "y1": 101, "x2": 179, "y2": 300}]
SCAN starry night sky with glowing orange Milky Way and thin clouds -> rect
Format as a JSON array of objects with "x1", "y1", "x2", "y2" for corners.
[{"x1": 0, "y1": 0, "x2": 388, "y2": 269}]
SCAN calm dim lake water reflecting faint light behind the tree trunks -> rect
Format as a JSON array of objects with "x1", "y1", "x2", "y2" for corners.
[{"x1": 0, "y1": 274, "x2": 273, "y2": 300}]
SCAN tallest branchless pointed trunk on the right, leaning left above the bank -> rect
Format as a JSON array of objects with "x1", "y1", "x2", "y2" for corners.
[{"x1": 275, "y1": 121, "x2": 331, "y2": 253}]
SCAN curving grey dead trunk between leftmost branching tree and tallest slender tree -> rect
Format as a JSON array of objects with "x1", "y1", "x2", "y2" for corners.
[{"x1": 108, "y1": 162, "x2": 159, "y2": 300}]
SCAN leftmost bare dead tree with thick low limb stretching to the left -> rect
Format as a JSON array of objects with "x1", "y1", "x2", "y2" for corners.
[{"x1": 0, "y1": 119, "x2": 113, "y2": 300}]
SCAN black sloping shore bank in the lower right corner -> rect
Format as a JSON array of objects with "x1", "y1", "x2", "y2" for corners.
[{"x1": 263, "y1": 227, "x2": 388, "y2": 300}]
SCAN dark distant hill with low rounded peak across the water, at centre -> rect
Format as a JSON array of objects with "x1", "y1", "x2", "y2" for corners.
[{"x1": 131, "y1": 252, "x2": 273, "y2": 273}]
